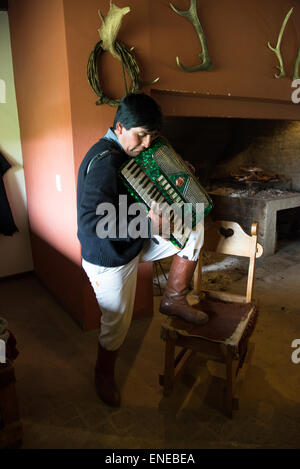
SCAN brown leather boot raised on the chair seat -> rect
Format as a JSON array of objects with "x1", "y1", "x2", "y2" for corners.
[{"x1": 159, "y1": 256, "x2": 208, "y2": 325}]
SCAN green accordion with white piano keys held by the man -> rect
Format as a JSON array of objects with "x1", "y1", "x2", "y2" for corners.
[{"x1": 119, "y1": 137, "x2": 212, "y2": 249}]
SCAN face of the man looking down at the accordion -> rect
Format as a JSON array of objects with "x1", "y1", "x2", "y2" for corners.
[{"x1": 115, "y1": 122, "x2": 158, "y2": 157}]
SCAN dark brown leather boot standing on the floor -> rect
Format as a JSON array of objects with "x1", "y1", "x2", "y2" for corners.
[{"x1": 95, "y1": 344, "x2": 121, "y2": 407}]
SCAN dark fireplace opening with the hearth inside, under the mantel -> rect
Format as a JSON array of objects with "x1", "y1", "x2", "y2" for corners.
[{"x1": 164, "y1": 117, "x2": 300, "y2": 256}]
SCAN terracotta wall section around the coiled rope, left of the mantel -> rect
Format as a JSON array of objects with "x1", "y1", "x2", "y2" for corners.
[{"x1": 64, "y1": 0, "x2": 150, "y2": 170}]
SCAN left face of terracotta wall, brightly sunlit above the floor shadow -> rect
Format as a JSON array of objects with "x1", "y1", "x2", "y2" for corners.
[{"x1": 9, "y1": 0, "x2": 77, "y2": 259}]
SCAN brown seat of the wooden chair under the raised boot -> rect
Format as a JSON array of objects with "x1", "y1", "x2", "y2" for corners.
[{"x1": 162, "y1": 298, "x2": 258, "y2": 359}]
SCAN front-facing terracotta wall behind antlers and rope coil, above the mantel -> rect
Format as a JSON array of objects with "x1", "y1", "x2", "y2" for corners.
[{"x1": 64, "y1": 0, "x2": 300, "y2": 121}]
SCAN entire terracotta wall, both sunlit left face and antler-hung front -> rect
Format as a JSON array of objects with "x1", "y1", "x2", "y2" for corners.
[{"x1": 9, "y1": 0, "x2": 300, "y2": 328}]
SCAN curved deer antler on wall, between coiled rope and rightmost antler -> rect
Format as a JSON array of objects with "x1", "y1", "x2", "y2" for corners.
[{"x1": 170, "y1": 0, "x2": 213, "y2": 72}]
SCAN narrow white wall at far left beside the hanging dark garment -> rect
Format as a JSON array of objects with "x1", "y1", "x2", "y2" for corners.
[{"x1": 0, "y1": 11, "x2": 33, "y2": 277}]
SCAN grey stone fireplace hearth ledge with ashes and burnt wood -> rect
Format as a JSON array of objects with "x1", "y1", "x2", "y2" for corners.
[{"x1": 206, "y1": 167, "x2": 300, "y2": 257}]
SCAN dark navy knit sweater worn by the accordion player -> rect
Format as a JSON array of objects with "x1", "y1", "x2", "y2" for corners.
[{"x1": 77, "y1": 137, "x2": 145, "y2": 267}]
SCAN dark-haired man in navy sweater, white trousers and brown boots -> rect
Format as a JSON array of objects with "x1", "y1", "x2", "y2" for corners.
[{"x1": 77, "y1": 93, "x2": 208, "y2": 406}]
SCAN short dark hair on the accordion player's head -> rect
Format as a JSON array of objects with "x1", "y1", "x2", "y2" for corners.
[{"x1": 113, "y1": 93, "x2": 162, "y2": 132}]
